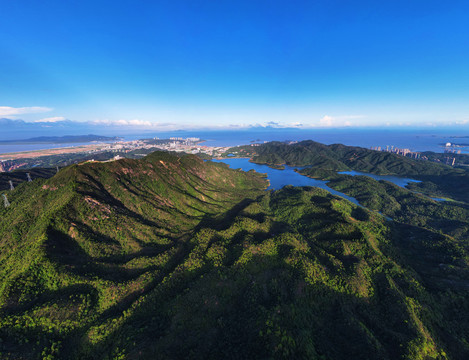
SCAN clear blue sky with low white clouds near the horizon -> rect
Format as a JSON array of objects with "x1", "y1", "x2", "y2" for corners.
[{"x1": 0, "y1": 0, "x2": 469, "y2": 130}]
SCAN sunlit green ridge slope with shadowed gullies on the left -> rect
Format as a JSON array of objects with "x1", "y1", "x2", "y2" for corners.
[{"x1": 0, "y1": 153, "x2": 267, "y2": 358}]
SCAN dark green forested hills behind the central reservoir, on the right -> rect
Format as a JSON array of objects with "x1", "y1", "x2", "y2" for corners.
[{"x1": 231, "y1": 140, "x2": 469, "y2": 203}]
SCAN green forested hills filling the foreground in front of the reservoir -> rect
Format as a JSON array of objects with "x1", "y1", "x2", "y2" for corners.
[{"x1": 0, "y1": 152, "x2": 469, "y2": 360}]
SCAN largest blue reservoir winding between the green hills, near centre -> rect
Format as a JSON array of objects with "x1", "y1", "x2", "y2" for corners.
[{"x1": 212, "y1": 159, "x2": 360, "y2": 205}]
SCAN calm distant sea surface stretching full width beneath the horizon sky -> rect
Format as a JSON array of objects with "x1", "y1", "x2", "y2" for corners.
[{"x1": 0, "y1": 128, "x2": 469, "y2": 154}]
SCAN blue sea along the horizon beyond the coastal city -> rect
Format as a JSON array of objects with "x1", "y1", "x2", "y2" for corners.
[{"x1": 0, "y1": 127, "x2": 469, "y2": 154}]
